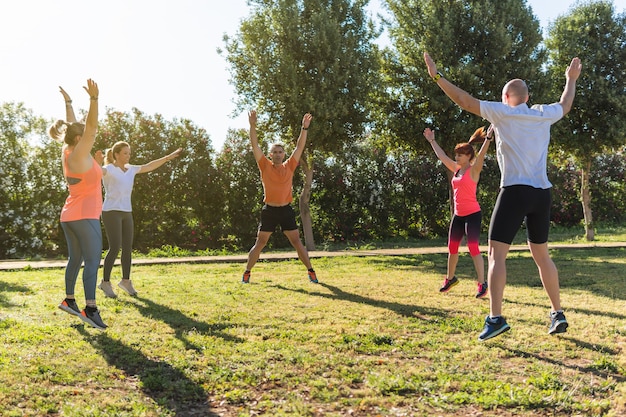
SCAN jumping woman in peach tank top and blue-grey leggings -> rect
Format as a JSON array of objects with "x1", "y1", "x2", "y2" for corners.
[{"x1": 49, "y1": 79, "x2": 107, "y2": 330}]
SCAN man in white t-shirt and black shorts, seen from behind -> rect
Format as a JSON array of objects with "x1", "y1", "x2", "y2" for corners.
[{"x1": 424, "y1": 52, "x2": 582, "y2": 341}]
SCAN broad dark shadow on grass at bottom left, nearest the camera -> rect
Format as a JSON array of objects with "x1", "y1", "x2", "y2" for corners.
[{"x1": 77, "y1": 326, "x2": 219, "y2": 417}]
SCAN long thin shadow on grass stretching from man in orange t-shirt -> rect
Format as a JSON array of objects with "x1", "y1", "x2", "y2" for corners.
[{"x1": 275, "y1": 282, "x2": 448, "y2": 320}]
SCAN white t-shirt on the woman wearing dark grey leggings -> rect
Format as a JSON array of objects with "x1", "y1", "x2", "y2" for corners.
[{"x1": 102, "y1": 164, "x2": 141, "y2": 211}]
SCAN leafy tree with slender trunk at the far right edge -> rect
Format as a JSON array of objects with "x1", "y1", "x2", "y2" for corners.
[{"x1": 546, "y1": 1, "x2": 626, "y2": 240}]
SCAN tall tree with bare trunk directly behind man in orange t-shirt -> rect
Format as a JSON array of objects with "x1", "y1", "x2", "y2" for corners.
[{"x1": 224, "y1": 0, "x2": 378, "y2": 250}]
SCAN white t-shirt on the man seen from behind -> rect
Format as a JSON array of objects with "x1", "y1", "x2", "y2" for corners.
[{"x1": 480, "y1": 100, "x2": 563, "y2": 189}]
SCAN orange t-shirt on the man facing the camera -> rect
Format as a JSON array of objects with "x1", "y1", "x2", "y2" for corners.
[{"x1": 257, "y1": 157, "x2": 298, "y2": 206}]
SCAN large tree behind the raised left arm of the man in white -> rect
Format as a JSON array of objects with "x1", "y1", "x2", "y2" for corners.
[{"x1": 377, "y1": 0, "x2": 545, "y2": 210}]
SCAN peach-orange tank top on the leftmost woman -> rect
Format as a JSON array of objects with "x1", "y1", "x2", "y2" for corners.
[{"x1": 61, "y1": 149, "x2": 102, "y2": 222}]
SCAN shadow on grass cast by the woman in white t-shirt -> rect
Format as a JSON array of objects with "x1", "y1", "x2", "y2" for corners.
[{"x1": 128, "y1": 296, "x2": 243, "y2": 352}]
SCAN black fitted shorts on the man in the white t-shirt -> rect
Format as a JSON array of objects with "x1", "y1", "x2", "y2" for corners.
[{"x1": 489, "y1": 185, "x2": 552, "y2": 245}]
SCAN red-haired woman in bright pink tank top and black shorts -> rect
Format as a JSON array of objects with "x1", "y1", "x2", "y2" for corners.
[{"x1": 424, "y1": 127, "x2": 492, "y2": 298}]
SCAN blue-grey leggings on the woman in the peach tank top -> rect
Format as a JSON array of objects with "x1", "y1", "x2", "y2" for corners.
[{"x1": 61, "y1": 219, "x2": 102, "y2": 300}]
